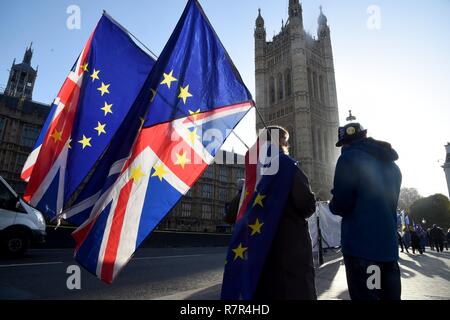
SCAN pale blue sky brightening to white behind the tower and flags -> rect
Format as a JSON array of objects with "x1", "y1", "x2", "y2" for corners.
[{"x1": 0, "y1": 0, "x2": 450, "y2": 195}]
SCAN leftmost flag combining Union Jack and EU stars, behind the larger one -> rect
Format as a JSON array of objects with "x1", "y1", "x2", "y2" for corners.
[{"x1": 22, "y1": 14, "x2": 155, "y2": 218}]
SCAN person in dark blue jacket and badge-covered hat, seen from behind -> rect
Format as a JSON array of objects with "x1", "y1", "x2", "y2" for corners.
[{"x1": 330, "y1": 123, "x2": 402, "y2": 300}]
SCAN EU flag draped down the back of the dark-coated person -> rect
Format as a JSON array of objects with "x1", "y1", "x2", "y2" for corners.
[{"x1": 221, "y1": 144, "x2": 297, "y2": 300}]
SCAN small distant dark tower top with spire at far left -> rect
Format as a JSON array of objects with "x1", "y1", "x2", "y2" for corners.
[{"x1": 5, "y1": 43, "x2": 37, "y2": 100}]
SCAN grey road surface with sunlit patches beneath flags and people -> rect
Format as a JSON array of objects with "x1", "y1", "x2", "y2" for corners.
[{"x1": 0, "y1": 247, "x2": 450, "y2": 300}]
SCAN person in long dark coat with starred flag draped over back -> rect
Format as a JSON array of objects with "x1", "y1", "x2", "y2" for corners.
[{"x1": 227, "y1": 126, "x2": 317, "y2": 300}]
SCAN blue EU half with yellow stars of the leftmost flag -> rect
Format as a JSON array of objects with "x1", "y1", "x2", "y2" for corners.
[{"x1": 33, "y1": 14, "x2": 155, "y2": 224}]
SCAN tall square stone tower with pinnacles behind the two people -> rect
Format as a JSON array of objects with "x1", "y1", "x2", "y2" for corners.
[{"x1": 254, "y1": 0, "x2": 339, "y2": 200}]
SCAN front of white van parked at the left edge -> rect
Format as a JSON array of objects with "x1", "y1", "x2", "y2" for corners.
[{"x1": 0, "y1": 176, "x2": 46, "y2": 257}]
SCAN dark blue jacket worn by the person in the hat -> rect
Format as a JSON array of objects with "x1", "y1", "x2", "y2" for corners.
[{"x1": 330, "y1": 138, "x2": 402, "y2": 262}]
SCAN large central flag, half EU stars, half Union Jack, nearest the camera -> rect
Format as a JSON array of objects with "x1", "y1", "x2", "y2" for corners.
[{"x1": 73, "y1": 0, "x2": 254, "y2": 283}]
